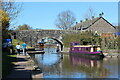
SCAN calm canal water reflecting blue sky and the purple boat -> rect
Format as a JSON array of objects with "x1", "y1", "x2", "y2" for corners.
[{"x1": 31, "y1": 48, "x2": 118, "y2": 78}]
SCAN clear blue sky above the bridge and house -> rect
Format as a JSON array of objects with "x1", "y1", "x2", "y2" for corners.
[{"x1": 12, "y1": 2, "x2": 118, "y2": 29}]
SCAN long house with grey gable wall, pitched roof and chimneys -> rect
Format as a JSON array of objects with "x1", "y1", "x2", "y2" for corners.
[{"x1": 70, "y1": 15, "x2": 117, "y2": 34}]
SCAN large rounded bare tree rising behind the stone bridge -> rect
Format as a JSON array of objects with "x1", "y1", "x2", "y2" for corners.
[{"x1": 55, "y1": 10, "x2": 76, "y2": 30}]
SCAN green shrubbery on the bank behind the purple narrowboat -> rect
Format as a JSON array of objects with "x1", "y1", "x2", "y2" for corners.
[{"x1": 63, "y1": 31, "x2": 102, "y2": 47}]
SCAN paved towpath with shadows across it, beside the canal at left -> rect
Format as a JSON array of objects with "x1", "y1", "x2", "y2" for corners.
[{"x1": 6, "y1": 53, "x2": 43, "y2": 80}]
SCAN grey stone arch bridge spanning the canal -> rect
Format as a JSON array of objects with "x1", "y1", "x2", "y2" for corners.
[{"x1": 13, "y1": 30, "x2": 79, "y2": 50}]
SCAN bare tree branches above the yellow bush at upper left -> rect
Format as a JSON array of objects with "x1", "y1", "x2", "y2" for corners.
[{"x1": 0, "y1": 0, "x2": 22, "y2": 29}]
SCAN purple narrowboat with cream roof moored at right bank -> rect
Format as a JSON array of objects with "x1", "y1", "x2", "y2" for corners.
[{"x1": 69, "y1": 42, "x2": 104, "y2": 59}]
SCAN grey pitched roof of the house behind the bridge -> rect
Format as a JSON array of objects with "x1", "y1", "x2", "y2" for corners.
[{"x1": 71, "y1": 17, "x2": 115, "y2": 30}]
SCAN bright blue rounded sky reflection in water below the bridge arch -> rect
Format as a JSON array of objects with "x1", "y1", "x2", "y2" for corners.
[{"x1": 35, "y1": 48, "x2": 60, "y2": 66}]
